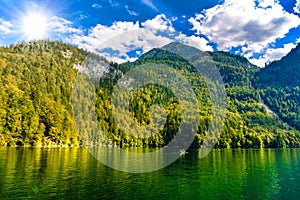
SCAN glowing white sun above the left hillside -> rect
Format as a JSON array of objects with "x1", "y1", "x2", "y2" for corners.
[{"x1": 22, "y1": 13, "x2": 48, "y2": 40}]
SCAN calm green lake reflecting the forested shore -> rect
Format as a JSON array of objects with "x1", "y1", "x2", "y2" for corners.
[{"x1": 0, "y1": 147, "x2": 300, "y2": 199}]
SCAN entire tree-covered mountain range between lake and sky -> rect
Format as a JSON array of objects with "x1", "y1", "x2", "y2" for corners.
[{"x1": 0, "y1": 41, "x2": 300, "y2": 147}]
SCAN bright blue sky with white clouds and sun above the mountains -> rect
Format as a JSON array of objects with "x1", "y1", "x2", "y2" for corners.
[{"x1": 0, "y1": 0, "x2": 300, "y2": 67}]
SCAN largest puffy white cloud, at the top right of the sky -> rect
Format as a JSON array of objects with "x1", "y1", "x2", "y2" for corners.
[{"x1": 189, "y1": 0, "x2": 300, "y2": 54}]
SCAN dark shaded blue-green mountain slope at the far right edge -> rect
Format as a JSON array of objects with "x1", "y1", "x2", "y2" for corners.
[{"x1": 257, "y1": 45, "x2": 300, "y2": 130}]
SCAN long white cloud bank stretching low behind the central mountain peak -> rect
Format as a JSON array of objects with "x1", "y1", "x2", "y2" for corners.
[{"x1": 68, "y1": 14, "x2": 212, "y2": 63}]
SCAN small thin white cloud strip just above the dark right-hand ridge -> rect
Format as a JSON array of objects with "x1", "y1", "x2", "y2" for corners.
[{"x1": 249, "y1": 43, "x2": 296, "y2": 67}]
